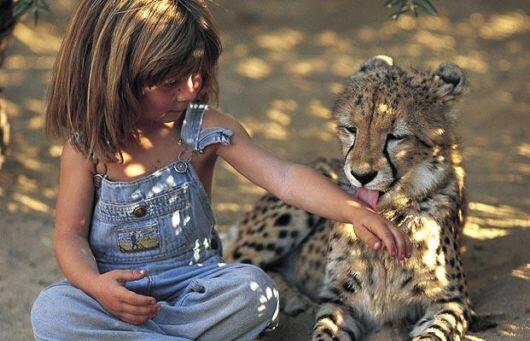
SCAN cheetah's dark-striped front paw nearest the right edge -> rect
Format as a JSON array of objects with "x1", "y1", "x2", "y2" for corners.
[{"x1": 410, "y1": 301, "x2": 468, "y2": 341}]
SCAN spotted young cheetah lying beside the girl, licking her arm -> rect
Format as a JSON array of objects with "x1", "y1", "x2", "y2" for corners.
[{"x1": 225, "y1": 56, "x2": 475, "y2": 340}]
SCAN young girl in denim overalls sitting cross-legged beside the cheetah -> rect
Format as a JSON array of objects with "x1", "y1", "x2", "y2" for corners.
[{"x1": 31, "y1": 0, "x2": 410, "y2": 340}]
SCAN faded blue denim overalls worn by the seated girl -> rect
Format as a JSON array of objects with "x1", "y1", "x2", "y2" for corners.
[{"x1": 31, "y1": 104, "x2": 279, "y2": 341}]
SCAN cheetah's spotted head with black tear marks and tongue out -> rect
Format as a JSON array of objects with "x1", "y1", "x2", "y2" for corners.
[{"x1": 333, "y1": 56, "x2": 467, "y2": 210}]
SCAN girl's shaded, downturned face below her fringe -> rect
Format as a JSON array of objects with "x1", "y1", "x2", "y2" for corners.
[{"x1": 139, "y1": 74, "x2": 202, "y2": 123}]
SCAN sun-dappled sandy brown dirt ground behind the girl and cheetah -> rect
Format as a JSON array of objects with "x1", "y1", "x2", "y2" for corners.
[{"x1": 0, "y1": 0, "x2": 530, "y2": 340}]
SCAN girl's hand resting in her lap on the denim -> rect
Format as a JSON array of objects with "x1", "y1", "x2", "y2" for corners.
[{"x1": 92, "y1": 270, "x2": 160, "y2": 325}]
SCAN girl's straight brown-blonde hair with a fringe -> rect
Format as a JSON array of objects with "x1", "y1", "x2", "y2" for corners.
[{"x1": 46, "y1": 0, "x2": 221, "y2": 162}]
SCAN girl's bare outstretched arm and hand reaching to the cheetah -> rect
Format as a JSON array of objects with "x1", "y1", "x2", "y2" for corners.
[{"x1": 206, "y1": 111, "x2": 412, "y2": 259}]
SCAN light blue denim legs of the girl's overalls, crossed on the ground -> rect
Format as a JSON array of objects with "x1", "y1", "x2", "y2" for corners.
[{"x1": 31, "y1": 256, "x2": 279, "y2": 341}]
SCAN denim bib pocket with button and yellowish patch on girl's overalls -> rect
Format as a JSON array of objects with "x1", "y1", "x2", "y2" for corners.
[{"x1": 90, "y1": 183, "x2": 195, "y2": 263}]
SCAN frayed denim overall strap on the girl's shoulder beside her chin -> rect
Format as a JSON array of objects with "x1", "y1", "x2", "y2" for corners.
[{"x1": 180, "y1": 103, "x2": 233, "y2": 153}]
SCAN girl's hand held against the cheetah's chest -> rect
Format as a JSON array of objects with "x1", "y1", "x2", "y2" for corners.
[{"x1": 352, "y1": 207, "x2": 412, "y2": 260}]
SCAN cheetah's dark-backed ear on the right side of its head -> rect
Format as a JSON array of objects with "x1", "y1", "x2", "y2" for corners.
[{"x1": 434, "y1": 63, "x2": 468, "y2": 101}]
